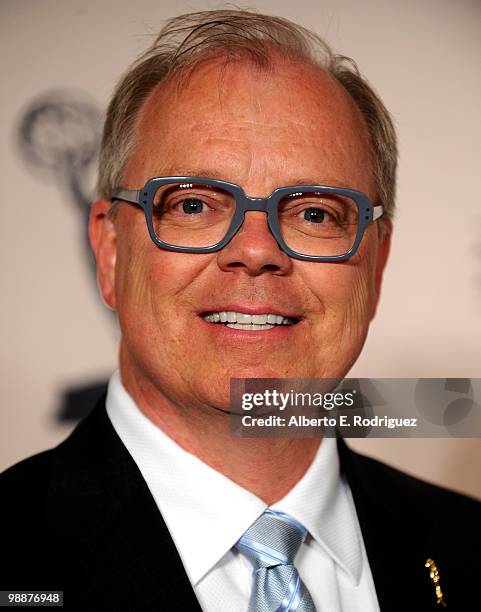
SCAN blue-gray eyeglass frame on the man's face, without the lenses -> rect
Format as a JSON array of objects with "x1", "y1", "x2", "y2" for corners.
[{"x1": 111, "y1": 176, "x2": 384, "y2": 262}]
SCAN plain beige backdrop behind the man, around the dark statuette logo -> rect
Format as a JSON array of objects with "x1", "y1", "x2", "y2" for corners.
[{"x1": 0, "y1": 0, "x2": 481, "y2": 497}]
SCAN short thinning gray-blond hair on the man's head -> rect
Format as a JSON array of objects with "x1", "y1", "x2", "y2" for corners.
[{"x1": 97, "y1": 9, "x2": 397, "y2": 218}]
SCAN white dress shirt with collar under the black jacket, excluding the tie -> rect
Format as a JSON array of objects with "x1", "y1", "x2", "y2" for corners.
[{"x1": 106, "y1": 371, "x2": 379, "y2": 612}]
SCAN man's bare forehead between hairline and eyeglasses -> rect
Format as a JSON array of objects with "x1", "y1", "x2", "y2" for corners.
[{"x1": 124, "y1": 58, "x2": 373, "y2": 195}]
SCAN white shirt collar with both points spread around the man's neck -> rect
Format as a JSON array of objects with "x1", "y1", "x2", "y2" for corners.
[{"x1": 106, "y1": 370, "x2": 362, "y2": 585}]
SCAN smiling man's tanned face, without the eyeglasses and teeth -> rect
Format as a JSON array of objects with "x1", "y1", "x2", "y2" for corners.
[{"x1": 91, "y1": 61, "x2": 388, "y2": 409}]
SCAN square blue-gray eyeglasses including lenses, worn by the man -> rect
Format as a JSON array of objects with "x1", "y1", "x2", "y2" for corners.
[{"x1": 112, "y1": 176, "x2": 383, "y2": 262}]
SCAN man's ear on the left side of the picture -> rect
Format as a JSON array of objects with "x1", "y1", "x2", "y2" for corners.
[{"x1": 89, "y1": 200, "x2": 117, "y2": 310}]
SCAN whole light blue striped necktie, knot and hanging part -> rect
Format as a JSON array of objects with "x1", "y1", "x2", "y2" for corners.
[{"x1": 236, "y1": 510, "x2": 316, "y2": 612}]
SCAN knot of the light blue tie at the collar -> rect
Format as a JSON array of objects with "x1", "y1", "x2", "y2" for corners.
[{"x1": 236, "y1": 510, "x2": 307, "y2": 569}]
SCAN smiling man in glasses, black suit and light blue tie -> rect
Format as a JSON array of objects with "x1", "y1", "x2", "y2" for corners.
[{"x1": 1, "y1": 10, "x2": 481, "y2": 612}]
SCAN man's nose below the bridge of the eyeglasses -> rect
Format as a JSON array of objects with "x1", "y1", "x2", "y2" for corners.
[{"x1": 217, "y1": 211, "x2": 292, "y2": 276}]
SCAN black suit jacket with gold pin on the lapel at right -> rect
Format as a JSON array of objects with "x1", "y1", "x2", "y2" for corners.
[{"x1": 0, "y1": 400, "x2": 481, "y2": 612}]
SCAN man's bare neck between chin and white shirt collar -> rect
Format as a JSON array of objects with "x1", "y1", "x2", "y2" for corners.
[{"x1": 121, "y1": 364, "x2": 320, "y2": 505}]
